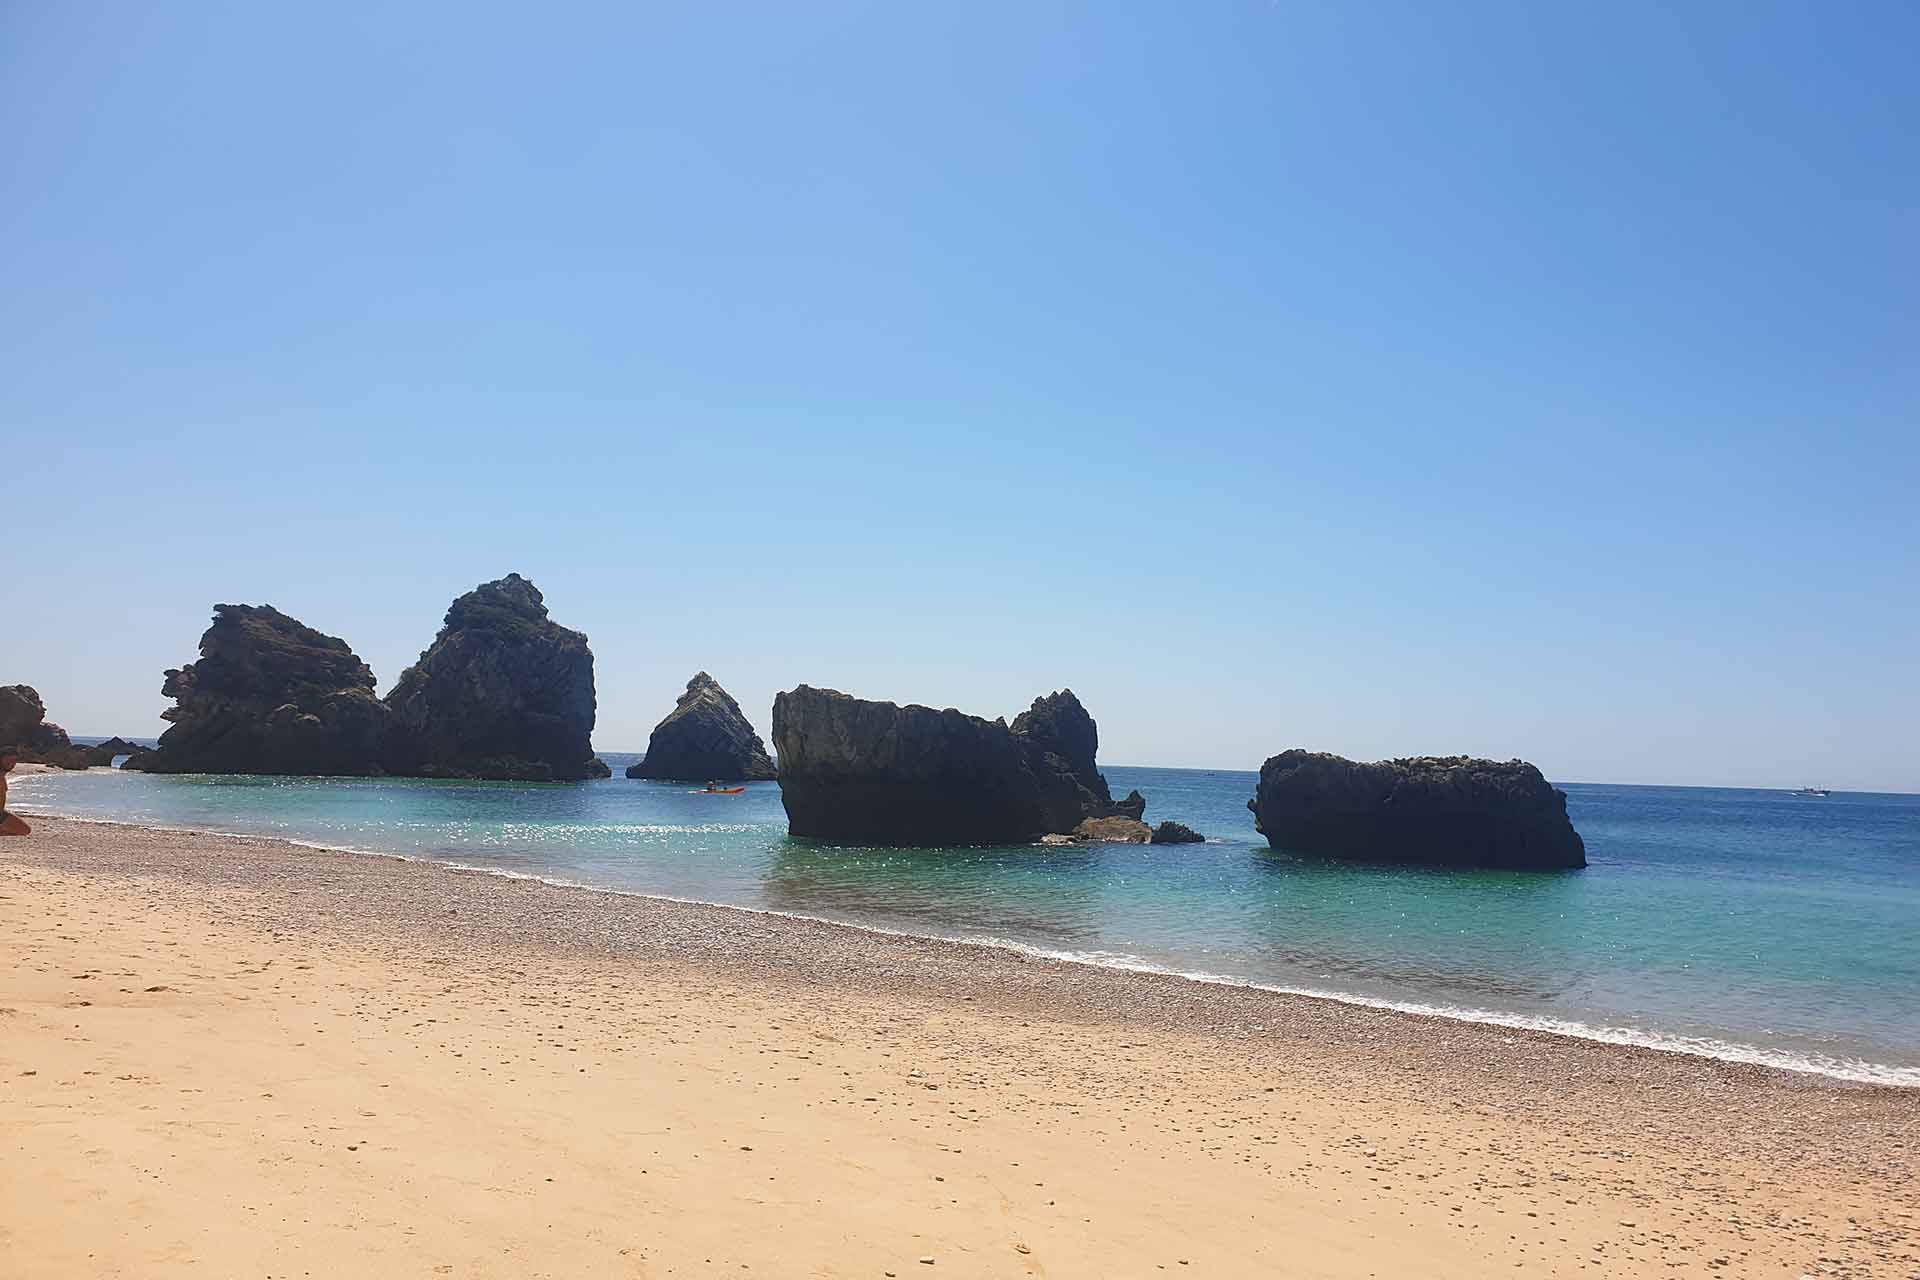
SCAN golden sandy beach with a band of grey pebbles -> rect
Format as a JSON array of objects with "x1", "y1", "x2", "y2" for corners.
[{"x1": 0, "y1": 818, "x2": 1920, "y2": 1280}]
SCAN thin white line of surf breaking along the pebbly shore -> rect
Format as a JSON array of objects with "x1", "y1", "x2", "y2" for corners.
[{"x1": 15, "y1": 793, "x2": 1920, "y2": 1090}]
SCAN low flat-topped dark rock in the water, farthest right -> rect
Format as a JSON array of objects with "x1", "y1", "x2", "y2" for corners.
[{"x1": 1246, "y1": 750, "x2": 1586, "y2": 871}]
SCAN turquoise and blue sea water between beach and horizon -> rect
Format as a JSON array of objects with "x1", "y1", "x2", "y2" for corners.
[{"x1": 15, "y1": 767, "x2": 1920, "y2": 1084}]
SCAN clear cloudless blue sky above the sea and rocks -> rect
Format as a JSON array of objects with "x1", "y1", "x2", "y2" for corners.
[{"x1": 0, "y1": 0, "x2": 1920, "y2": 791}]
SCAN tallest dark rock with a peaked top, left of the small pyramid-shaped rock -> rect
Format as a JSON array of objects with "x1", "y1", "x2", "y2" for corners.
[{"x1": 386, "y1": 574, "x2": 593, "y2": 781}]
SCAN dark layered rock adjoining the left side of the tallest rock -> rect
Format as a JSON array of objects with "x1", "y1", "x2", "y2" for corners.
[{"x1": 136, "y1": 604, "x2": 392, "y2": 775}]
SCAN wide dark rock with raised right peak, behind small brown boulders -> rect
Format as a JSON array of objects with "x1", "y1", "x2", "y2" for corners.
[{"x1": 774, "y1": 685, "x2": 1144, "y2": 844}]
